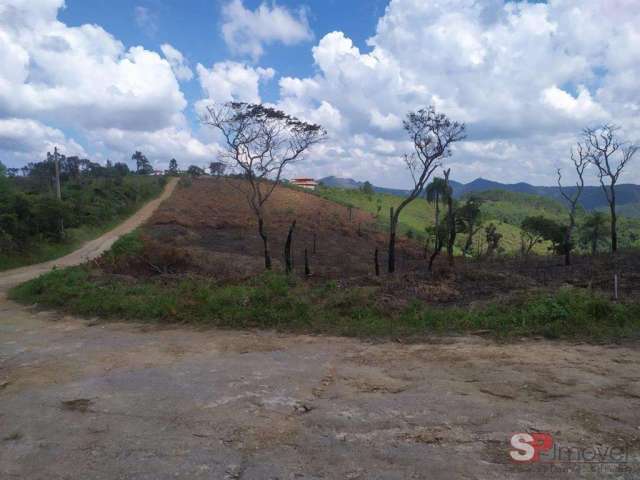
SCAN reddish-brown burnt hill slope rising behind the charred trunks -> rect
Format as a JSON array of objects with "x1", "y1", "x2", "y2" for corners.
[{"x1": 144, "y1": 178, "x2": 420, "y2": 279}]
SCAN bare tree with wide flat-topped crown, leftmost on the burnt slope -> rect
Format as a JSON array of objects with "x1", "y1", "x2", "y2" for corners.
[{"x1": 203, "y1": 102, "x2": 326, "y2": 270}]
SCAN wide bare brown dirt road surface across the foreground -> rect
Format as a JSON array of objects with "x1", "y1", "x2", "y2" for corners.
[{"x1": 0, "y1": 177, "x2": 640, "y2": 480}]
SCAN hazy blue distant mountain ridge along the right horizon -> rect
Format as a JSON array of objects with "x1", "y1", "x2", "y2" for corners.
[{"x1": 320, "y1": 177, "x2": 640, "y2": 218}]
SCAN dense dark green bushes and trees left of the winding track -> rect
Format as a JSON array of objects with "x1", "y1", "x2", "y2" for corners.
[{"x1": 0, "y1": 156, "x2": 164, "y2": 270}]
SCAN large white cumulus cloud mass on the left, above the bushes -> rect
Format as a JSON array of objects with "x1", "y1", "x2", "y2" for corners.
[{"x1": 0, "y1": 0, "x2": 220, "y2": 169}]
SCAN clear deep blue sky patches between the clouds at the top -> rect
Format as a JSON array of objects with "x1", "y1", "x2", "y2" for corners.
[{"x1": 59, "y1": 0, "x2": 389, "y2": 121}]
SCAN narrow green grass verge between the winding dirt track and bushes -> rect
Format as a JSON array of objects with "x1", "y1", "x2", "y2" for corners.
[{"x1": 0, "y1": 177, "x2": 162, "y2": 272}]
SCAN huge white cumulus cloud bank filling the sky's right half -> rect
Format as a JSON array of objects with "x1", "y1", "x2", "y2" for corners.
[{"x1": 279, "y1": 0, "x2": 640, "y2": 187}]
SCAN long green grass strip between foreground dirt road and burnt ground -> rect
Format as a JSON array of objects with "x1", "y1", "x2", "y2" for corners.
[{"x1": 10, "y1": 266, "x2": 640, "y2": 341}]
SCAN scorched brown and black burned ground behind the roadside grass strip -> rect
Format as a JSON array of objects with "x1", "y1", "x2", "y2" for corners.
[{"x1": 111, "y1": 178, "x2": 640, "y2": 305}]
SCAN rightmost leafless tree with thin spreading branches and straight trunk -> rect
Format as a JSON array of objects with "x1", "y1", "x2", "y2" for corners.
[{"x1": 583, "y1": 125, "x2": 638, "y2": 253}]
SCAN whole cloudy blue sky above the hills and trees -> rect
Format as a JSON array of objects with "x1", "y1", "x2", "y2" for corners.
[{"x1": 0, "y1": 0, "x2": 640, "y2": 188}]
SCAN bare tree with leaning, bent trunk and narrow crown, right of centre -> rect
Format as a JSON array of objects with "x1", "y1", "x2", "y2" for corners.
[{"x1": 388, "y1": 106, "x2": 464, "y2": 273}]
